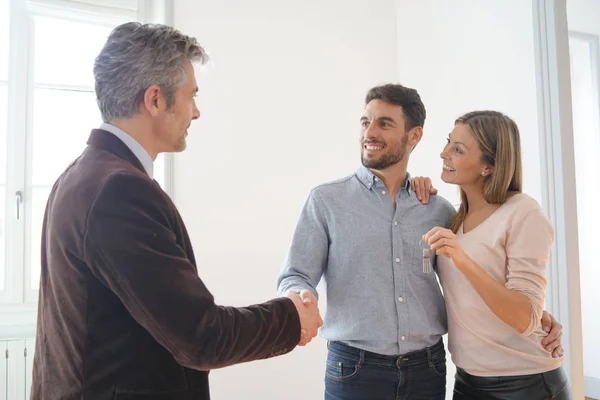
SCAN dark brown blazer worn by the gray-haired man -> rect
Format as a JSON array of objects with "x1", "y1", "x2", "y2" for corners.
[{"x1": 31, "y1": 130, "x2": 300, "y2": 400}]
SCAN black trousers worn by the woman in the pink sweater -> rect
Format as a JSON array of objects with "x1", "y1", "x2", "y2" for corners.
[{"x1": 453, "y1": 367, "x2": 572, "y2": 400}]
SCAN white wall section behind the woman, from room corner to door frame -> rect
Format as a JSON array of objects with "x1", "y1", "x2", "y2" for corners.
[{"x1": 398, "y1": 0, "x2": 541, "y2": 398}]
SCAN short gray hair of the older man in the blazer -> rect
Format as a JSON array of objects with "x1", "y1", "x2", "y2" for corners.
[{"x1": 94, "y1": 22, "x2": 208, "y2": 122}]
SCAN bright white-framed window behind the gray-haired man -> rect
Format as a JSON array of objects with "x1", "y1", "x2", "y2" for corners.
[{"x1": 0, "y1": 0, "x2": 169, "y2": 328}]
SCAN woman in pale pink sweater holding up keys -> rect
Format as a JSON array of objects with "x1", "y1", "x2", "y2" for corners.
[{"x1": 423, "y1": 111, "x2": 571, "y2": 400}]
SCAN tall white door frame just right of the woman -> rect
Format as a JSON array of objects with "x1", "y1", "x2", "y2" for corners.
[{"x1": 533, "y1": 0, "x2": 584, "y2": 398}]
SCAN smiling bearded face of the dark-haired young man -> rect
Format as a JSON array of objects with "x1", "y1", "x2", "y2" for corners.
[{"x1": 360, "y1": 99, "x2": 409, "y2": 170}]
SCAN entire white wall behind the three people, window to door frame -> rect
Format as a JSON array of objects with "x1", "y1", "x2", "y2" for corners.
[{"x1": 175, "y1": 0, "x2": 541, "y2": 399}]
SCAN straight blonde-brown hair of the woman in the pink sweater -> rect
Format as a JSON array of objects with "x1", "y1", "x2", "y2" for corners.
[{"x1": 450, "y1": 111, "x2": 523, "y2": 233}]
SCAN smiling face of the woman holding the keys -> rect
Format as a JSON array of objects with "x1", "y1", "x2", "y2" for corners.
[{"x1": 440, "y1": 122, "x2": 492, "y2": 186}]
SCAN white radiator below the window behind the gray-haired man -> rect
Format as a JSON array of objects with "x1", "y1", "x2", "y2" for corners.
[{"x1": 0, "y1": 338, "x2": 35, "y2": 400}]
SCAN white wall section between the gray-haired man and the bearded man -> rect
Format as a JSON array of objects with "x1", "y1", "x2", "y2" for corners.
[{"x1": 175, "y1": 0, "x2": 398, "y2": 400}]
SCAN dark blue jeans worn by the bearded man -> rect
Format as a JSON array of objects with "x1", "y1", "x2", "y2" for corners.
[{"x1": 325, "y1": 340, "x2": 446, "y2": 400}]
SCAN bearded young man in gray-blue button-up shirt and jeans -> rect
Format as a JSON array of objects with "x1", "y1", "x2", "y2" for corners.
[{"x1": 278, "y1": 84, "x2": 562, "y2": 400}]
